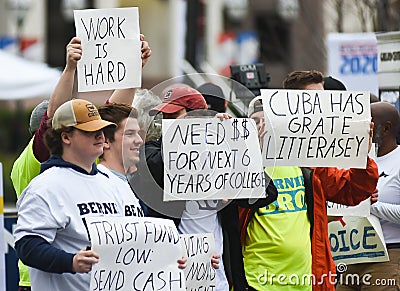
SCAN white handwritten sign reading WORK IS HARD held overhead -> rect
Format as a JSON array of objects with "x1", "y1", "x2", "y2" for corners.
[{"x1": 74, "y1": 7, "x2": 142, "y2": 92}]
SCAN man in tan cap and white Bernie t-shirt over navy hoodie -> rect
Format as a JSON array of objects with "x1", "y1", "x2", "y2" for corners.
[{"x1": 14, "y1": 99, "x2": 123, "y2": 291}]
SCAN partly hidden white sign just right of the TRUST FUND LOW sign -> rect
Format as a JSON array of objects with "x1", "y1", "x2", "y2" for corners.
[{"x1": 180, "y1": 233, "x2": 216, "y2": 291}]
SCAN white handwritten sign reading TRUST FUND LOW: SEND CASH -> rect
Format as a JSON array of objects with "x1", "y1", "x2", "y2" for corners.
[{"x1": 87, "y1": 217, "x2": 185, "y2": 291}]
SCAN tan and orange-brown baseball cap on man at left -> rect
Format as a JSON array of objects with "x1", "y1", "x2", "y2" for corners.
[{"x1": 51, "y1": 99, "x2": 117, "y2": 131}]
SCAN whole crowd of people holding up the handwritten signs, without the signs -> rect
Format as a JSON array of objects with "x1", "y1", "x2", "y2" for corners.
[{"x1": 11, "y1": 32, "x2": 400, "y2": 291}]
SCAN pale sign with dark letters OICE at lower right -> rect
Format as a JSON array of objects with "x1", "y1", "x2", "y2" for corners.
[{"x1": 328, "y1": 215, "x2": 389, "y2": 265}]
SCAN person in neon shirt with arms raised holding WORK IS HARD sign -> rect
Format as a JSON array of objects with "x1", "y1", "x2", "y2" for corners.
[{"x1": 11, "y1": 35, "x2": 151, "y2": 291}]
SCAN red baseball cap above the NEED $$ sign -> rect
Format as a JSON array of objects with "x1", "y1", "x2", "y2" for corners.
[{"x1": 149, "y1": 87, "x2": 207, "y2": 116}]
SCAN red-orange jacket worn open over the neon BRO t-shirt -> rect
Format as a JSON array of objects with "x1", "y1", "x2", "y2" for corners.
[{"x1": 311, "y1": 158, "x2": 378, "y2": 291}]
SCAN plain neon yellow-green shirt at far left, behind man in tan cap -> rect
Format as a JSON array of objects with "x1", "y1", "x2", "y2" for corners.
[{"x1": 11, "y1": 137, "x2": 40, "y2": 286}]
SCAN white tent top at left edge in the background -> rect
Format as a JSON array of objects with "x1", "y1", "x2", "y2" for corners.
[{"x1": 0, "y1": 50, "x2": 61, "y2": 100}]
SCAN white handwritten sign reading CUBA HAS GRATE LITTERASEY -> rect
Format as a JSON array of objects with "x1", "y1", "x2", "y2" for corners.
[{"x1": 261, "y1": 90, "x2": 371, "y2": 169}]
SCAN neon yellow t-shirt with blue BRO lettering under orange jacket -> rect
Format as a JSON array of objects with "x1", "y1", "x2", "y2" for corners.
[{"x1": 243, "y1": 167, "x2": 312, "y2": 291}]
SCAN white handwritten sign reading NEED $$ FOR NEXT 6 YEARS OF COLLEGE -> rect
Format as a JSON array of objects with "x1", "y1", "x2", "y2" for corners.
[{"x1": 162, "y1": 118, "x2": 268, "y2": 201}]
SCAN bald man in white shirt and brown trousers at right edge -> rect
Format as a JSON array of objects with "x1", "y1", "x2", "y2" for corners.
[{"x1": 336, "y1": 102, "x2": 400, "y2": 291}]
